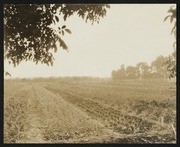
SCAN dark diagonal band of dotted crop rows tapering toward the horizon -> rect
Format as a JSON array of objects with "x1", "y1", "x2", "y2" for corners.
[{"x1": 47, "y1": 88, "x2": 163, "y2": 134}]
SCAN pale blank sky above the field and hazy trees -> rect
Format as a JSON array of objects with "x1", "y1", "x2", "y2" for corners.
[{"x1": 4, "y1": 4, "x2": 175, "y2": 78}]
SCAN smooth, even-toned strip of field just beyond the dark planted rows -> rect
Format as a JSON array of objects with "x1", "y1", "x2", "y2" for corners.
[{"x1": 44, "y1": 83, "x2": 176, "y2": 107}]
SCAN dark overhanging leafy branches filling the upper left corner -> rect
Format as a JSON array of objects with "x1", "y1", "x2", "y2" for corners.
[{"x1": 4, "y1": 4, "x2": 110, "y2": 66}]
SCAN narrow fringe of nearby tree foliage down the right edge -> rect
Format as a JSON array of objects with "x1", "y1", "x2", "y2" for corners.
[{"x1": 164, "y1": 6, "x2": 176, "y2": 78}]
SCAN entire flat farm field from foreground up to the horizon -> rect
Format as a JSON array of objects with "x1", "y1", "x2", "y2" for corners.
[{"x1": 4, "y1": 78, "x2": 176, "y2": 144}]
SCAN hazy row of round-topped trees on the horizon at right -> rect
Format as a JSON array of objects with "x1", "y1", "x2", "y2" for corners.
[{"x1": 111, "y1": 55, "x2": 173, "y2": 80}]
